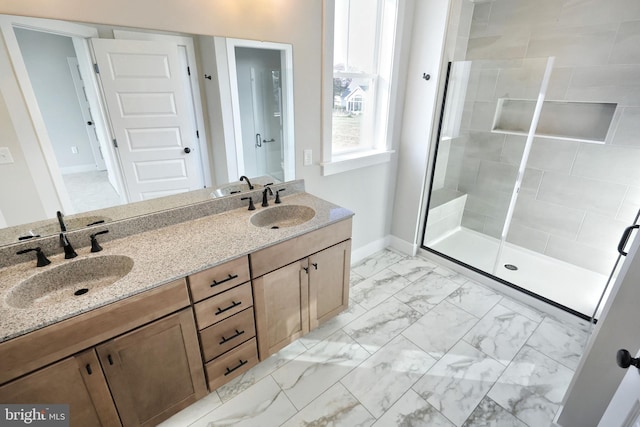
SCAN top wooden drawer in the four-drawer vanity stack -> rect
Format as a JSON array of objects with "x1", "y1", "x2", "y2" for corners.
[{"x1": 189, "y1": 256, "x2": 249, "y2": 302}]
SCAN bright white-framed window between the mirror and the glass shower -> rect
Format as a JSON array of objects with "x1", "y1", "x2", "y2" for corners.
[{"x1": 323, "y1": 0, "x2": 401, "y2": 175}]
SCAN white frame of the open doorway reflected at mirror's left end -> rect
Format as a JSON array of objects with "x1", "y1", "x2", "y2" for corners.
[{"x1": 0, "y1": 15, "x2": 127, "y2": 213}]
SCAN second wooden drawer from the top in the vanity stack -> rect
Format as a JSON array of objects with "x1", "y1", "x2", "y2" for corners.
[{"x1": 195, "y1": 283, "x2": 253, "y2": 330}]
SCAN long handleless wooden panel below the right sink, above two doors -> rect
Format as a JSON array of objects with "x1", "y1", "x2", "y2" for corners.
[{"x1": 250, "y1": 218, "x2": 351, "y2": 278}]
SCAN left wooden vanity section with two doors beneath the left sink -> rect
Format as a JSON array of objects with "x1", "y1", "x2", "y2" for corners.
[{"x1": 0, "y1": 279, "x2": 207, "y2": 427}]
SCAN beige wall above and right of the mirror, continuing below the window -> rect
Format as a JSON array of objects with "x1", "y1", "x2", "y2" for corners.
[{"x1": 0, "y1": 0, "x2": 395, "y2": 254}]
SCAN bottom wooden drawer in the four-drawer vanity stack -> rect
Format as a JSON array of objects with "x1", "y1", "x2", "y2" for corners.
[{"x1": 205, "y1": 338, "x2": 258, "y2": 391}]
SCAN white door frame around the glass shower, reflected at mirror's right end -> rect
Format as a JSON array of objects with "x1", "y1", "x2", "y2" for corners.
[{"x1": 215, "y1": 37, "x2": 295, "y2": 182}]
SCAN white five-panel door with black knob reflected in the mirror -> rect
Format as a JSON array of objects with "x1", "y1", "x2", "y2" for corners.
[{"x1": 92, "y1": 39, "x2": 204, "y2": 202}]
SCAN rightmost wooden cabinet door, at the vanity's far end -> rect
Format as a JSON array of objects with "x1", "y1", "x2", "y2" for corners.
[{"x1": 309, "y1": 240, "x2": 351, "y2": 329}]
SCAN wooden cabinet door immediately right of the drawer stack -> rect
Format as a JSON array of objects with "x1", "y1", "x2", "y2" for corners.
[{"x1": 253, "y1": 259, "x2": 309, "y2": 360}]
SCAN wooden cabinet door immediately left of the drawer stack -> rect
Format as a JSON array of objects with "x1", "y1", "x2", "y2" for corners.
[{"x1": 97, "y1": 309, "x2": 207, "y2": 426}]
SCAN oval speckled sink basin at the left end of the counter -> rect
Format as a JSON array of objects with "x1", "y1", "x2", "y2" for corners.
[{"x1": 5, "y1": 255, "x2": 133, "y2": 309}]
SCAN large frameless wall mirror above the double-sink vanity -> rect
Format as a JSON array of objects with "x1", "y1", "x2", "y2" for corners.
[{"x1": 0, "y1": 15, "x2": 295, "y2": 245}]
